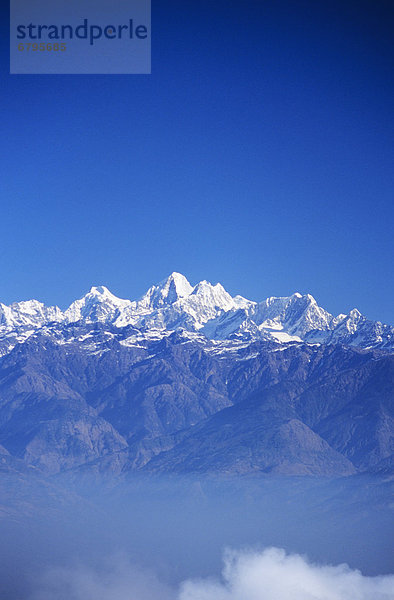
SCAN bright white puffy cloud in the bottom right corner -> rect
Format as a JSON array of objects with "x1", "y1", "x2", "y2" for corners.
[{"x1": 179, "y1": 548, "x2": 394, "y2": 600}]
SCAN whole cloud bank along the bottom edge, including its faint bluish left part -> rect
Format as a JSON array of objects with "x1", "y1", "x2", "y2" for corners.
[{"x1": 29, "y1": 548, "x2": 394, "y2": 600}]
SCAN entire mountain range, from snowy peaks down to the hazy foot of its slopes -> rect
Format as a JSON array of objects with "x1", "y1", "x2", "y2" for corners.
[{"x1": 0, "y1": 273, "x2": 394, "y2": 476}]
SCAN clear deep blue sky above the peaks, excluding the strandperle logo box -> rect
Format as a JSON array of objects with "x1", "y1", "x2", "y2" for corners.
[{"x1": 0, "y1": 0, "x2": 394, "y2": 323}]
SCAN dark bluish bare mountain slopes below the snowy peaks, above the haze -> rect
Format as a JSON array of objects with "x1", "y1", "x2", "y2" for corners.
[{"x1": 0, "y1": 323, "x2": 394, "y2": 475}]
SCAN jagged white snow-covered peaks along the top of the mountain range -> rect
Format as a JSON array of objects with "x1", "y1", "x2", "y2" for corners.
[{"x1": 0, "y1": 273, "x2": 394, "y2": 354}]
